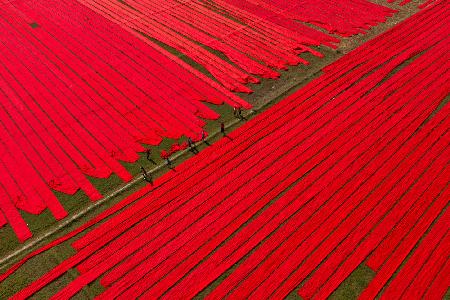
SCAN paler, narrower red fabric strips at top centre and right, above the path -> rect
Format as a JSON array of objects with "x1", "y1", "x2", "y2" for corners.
[{"x1": 71, "y1": 0, "x2": 395, "y2": 93}]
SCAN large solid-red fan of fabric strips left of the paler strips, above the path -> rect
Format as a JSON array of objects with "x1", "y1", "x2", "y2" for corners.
[{"x1": 0, "y1": 0, "x2": 251, "y2": 241}]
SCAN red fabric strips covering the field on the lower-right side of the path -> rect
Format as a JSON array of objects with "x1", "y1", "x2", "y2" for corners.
[{"x1": 1, "y1": 0, "x2": 450, "y2": 299}]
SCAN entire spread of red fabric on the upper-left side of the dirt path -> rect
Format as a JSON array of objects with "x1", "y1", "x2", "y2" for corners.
[{"x1": 0, "y1": 0, "x2": 394, "y2": 241}]
